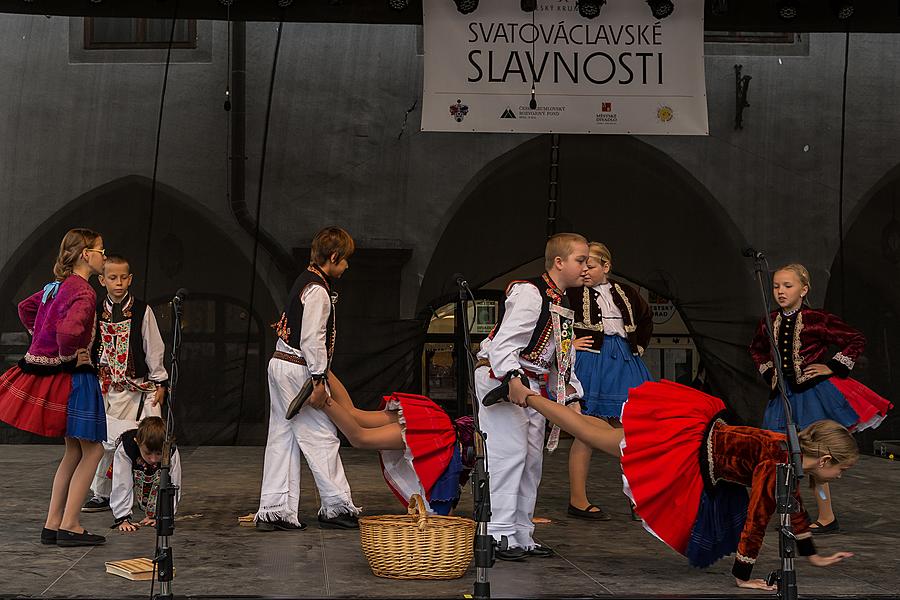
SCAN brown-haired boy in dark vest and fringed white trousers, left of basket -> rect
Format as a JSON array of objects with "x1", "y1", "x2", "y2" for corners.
[{"x1": 255, "y1": 227, "x2": 359, "y2": 531}]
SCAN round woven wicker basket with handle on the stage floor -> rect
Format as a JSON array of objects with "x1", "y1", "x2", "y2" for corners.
[{"x1": 359, "y1": 494, "x2": 475, "y2": 579}]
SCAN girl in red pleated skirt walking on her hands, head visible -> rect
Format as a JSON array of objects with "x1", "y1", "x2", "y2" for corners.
[{"x1": 500, "y1": 381, "x2": 859, "y2": 590}]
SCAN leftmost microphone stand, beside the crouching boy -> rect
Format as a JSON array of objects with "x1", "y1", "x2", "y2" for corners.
[{"x1": 150, "y1": 293, "x2": 182, "y2": 600}]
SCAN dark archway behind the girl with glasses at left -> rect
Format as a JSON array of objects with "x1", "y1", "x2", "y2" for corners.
[{"x1": 0, "y1": 176, "x2": 278, "y2": 445}]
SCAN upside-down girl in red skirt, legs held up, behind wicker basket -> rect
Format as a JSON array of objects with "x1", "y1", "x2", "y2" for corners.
[{"x1": 321, "y1": 372, "x2": 466, "y2": 515}]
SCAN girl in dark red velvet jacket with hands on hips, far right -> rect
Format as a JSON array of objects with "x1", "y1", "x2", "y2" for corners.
[{"x1": 750, "y1": 264, "x2": 892, "y2": 533}]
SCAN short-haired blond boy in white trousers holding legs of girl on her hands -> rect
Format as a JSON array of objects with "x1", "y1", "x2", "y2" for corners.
[{"x1": 475, "y1": 233, "x2": 588, "y2": 560}]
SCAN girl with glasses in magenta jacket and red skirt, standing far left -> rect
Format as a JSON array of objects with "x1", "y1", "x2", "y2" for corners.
[{"x1": 0, "y1": 229, "x2": 106, "y2": 546}]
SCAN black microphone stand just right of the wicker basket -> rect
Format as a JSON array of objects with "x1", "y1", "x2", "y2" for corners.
[{"x1": 456, "y1": 278, "x2": 505, "y2": 600}]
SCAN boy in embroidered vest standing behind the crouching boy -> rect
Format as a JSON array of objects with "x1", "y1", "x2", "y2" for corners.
[{"x1": 81, "y1": 254, "x2": 169, "y2": 512}]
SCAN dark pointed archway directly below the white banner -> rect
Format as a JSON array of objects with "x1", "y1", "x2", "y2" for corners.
[{"x1": 418, "y1": 135, "x2": 766, "y2": 423}]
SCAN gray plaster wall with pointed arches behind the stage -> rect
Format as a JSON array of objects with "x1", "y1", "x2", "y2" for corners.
[{"x1": 0, "y1": 15, "x2": 900, "y2": 428}]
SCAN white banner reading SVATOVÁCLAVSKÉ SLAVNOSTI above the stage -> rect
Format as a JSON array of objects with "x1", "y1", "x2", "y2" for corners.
[{"x1": 422, "y1": 0, "x2": 709, "y2": 135}]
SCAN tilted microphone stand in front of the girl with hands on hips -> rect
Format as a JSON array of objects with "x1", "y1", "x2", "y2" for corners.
[{"x1": 744, "y1": 248, "x2": 803, "y2": 600}]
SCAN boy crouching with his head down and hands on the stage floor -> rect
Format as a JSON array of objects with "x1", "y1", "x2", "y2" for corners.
[{"x1": 110, "y1": 417, "x2": 181, "y2": 531}]
